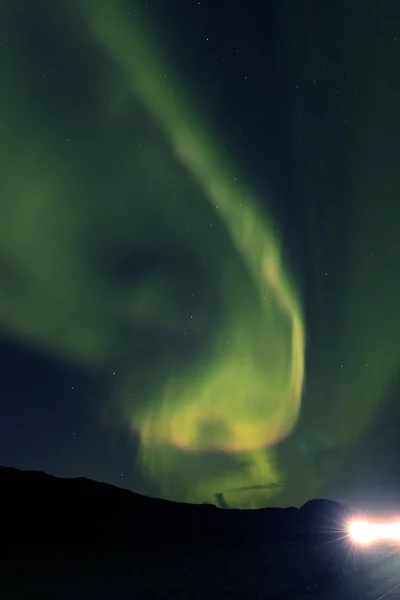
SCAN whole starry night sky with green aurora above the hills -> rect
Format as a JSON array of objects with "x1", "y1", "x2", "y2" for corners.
[{"x1": 0, "y1": 0, "x2": 400, "y2": 507}]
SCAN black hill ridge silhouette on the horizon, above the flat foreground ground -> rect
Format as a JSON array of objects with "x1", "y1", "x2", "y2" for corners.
[{"x1": 0, "y1": 467, "x2": 348, "y2": 552}]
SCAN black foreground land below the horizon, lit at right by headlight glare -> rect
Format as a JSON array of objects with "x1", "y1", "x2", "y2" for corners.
[{"x1": 0, "y1": 468, "x2": 400, "y2": 600}]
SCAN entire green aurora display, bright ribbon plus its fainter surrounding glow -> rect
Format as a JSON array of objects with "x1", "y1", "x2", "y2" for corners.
[{"x1": 0, "y1": 0, "x2": 400, "y2": 507}]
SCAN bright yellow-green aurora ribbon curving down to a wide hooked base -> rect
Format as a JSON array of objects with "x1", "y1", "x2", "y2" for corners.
[{"x1": 85, "y1": 0, "x2": 305, "y2": 505}]
